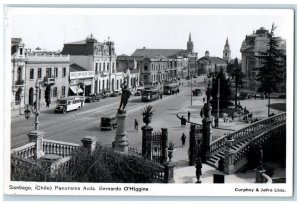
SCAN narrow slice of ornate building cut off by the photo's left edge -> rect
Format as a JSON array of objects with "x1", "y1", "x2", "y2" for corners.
[{"x1": 11, "y1": 38, "x2": 25, "y2": 109}]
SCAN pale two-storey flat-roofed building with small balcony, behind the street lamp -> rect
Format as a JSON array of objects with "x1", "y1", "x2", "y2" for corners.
[{"x1": 25, "y1": 50, "x2": 70, "y2": 105}]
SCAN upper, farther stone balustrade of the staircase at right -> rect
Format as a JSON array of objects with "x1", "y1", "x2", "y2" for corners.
[{"x1": 210, "y1": 113, "x2": 286, "y2": 156}]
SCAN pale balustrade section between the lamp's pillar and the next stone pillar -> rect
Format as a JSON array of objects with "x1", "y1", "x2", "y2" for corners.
[{"x1": 43, "y1": 140, "x2": 80, "y2": 157}]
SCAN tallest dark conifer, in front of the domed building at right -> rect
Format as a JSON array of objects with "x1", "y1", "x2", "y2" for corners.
[{"x1": 255, "y1": 23, "x2": 285, "y2": 116}]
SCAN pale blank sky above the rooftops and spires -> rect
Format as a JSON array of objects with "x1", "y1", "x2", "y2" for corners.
[{"x1": 6, "y1": 8, "x2": 293, "y2": 58}]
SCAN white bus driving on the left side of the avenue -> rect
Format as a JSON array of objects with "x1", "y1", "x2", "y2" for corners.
[{"x1": 54, "y1": 96, "x2": 84, "y2": 113}]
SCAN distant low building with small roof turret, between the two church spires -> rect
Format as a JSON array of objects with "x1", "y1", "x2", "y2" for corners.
[{"x1": 198, "y1": 51, "x2": 228, "y2": 73}]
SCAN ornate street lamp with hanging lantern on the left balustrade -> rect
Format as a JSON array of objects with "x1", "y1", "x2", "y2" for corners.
[{"x1": 24, "y1": 81, "x2": 41, "y2": 131}]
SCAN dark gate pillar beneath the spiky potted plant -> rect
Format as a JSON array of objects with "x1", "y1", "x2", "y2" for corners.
[{"x1": 141, "y1": 125, "x2": 153, "y2": 160}]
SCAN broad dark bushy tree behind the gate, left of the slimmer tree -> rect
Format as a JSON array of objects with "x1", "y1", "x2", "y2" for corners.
[{"x1": 211, "y1": 69, "x2": 232, "y2": 108}]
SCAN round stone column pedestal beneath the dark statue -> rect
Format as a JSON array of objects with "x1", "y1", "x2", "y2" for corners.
[{"x1": 113, "y1": 110, "x2": 128, "y2": 153}]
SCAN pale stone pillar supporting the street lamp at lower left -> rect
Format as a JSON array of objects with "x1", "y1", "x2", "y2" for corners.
[{"x1": 27, "y1": 130, "x2": 45, "y2": 160}]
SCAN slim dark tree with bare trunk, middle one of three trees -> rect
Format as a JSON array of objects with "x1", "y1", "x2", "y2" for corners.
[{"x1": 226, "y1": 58, "x2": 245, "y2": 109}]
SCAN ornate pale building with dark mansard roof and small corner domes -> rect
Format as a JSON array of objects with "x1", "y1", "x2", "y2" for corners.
[{"x1": 61, "y1": 34, "x2": 119, "y2": 95}]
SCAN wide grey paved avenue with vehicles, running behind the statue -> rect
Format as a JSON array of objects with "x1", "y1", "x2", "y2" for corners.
[{"x1": 11, "y1": 79, "x2": 206, "y2": 149}]
